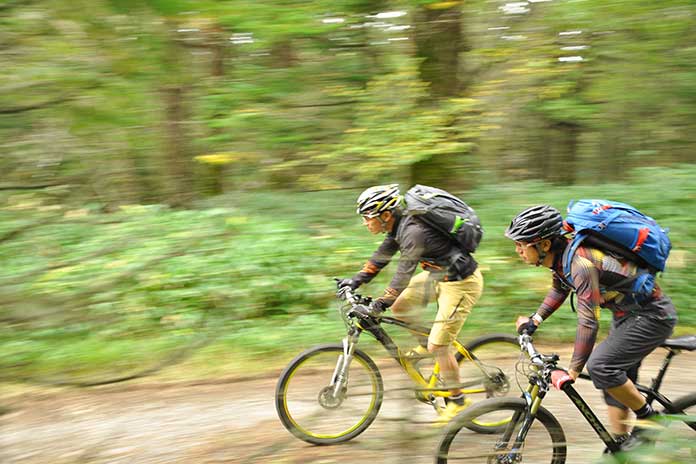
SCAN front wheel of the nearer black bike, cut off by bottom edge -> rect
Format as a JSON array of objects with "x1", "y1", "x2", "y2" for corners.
[{"x1": 435, "y1": 398, "x2": 567, "y2": 464}]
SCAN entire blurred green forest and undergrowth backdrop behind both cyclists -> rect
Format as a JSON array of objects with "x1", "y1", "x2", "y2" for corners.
[{"x1": 0, "y1": 0, "x2": 696, "y2": 420}]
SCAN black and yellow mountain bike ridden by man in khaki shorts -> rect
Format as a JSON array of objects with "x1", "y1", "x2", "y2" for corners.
[{"x1": 275, "y1": 289, "x2": 519, "y2": 445}]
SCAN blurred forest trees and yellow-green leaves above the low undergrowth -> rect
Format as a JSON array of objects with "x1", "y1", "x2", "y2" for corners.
[{"x1": 0, "y1": 0, "x2": 696, "y2": 203}]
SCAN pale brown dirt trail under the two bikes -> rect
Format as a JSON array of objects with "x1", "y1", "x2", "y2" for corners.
[{"x1": 0, "y1": 346, "x2": 696, "y2": 464}]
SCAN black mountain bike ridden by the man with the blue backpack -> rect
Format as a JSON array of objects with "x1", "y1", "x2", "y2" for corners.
[{"x1": 435, "y1": 334, "x2": 696, "y2": 464}]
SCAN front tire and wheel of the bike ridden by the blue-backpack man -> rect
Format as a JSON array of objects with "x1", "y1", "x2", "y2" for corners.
[{"x1": 435, "y1": 398, "x2": 567, "y2": 464}]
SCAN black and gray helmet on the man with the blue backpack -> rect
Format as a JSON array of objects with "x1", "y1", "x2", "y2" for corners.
[{"x1": 505, "y1": 205, "x2": 564, "y2": 242}]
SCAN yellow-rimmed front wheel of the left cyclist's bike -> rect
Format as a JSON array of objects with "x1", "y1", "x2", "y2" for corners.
[{"x1": 276, "y1": 344, "x2": 384, "y2": 445}]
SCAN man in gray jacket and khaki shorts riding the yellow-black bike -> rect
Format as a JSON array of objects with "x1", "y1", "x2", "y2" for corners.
[{"x1": 339, "y1": 184, "x2": 483, "y2": 422}]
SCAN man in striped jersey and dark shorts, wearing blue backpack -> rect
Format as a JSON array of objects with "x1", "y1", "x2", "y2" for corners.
[{"x1": 505, "y1": 205, "x2": 677, "y2": 449}]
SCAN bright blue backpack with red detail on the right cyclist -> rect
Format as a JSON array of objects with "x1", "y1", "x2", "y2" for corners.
[{"x1": 563, "y1": 200, "x2": 672, "y2": 302}]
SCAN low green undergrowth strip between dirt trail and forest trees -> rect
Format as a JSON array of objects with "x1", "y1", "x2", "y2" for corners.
[{"x1": 0, "y1": 165, "x2": 696, "y2": 378}]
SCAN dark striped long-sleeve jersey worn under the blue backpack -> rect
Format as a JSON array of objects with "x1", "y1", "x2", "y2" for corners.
[{"x1": 537, "y1": 246, "x2": 662, "y2": 372}]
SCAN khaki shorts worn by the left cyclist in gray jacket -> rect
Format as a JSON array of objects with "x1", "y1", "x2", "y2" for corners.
[{"x1": 394, "y1": 269, "x2": 483, "y2": 345}]
